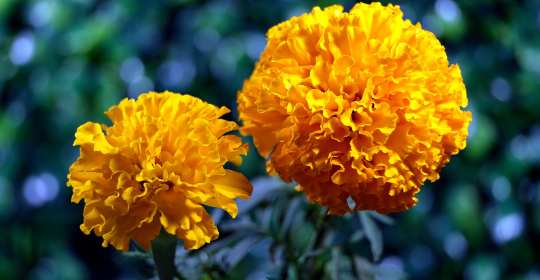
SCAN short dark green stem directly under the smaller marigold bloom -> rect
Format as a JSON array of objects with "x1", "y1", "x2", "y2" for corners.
[{"x1": 152, "y1": 232, "x2": 178, "y2": 280}]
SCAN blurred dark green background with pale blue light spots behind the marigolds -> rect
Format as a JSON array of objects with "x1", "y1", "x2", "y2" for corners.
[{"x1": 0, "y1": 0, "x2": 540, "y2": 279}]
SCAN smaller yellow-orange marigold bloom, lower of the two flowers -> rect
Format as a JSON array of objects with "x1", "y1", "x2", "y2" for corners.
[{"x1": 68, "y1": 92, "x2": 252, "y2": 250}]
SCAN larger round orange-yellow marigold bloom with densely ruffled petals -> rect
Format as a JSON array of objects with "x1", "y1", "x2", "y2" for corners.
[{"x1": 238, "y1": 3, "x2": 471, "y2": 214}]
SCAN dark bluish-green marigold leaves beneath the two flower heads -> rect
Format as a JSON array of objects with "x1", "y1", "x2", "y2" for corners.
[{"x1": 128, "y1": 177, "x2": 404, "y2": 279}]
